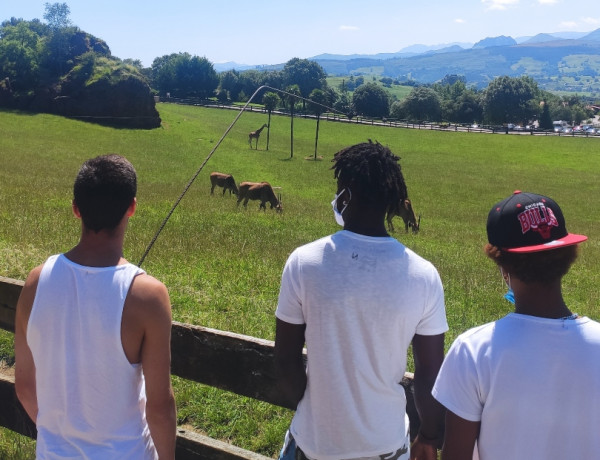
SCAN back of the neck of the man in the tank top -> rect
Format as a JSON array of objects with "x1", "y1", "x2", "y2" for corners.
[{"x1": 65, "y1": 229, "x2": 127, "y2": 267}]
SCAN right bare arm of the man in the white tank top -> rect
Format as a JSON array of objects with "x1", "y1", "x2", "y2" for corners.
[{"x1": 134, "y1": 275, "x2": 177, "y2": 460}]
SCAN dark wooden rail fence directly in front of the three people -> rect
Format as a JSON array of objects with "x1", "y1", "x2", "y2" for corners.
[{"x1": 0, "y1": 276, "x2": 419, "y2": 460}]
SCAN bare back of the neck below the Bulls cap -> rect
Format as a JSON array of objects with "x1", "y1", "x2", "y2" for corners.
[{"x1": 513, "y1": 282, "x2": 572, "y2": 319}]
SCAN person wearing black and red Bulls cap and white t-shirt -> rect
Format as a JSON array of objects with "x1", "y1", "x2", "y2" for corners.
[{"x1": 432, "y1": 191, "x2": 600, "y2": 460}]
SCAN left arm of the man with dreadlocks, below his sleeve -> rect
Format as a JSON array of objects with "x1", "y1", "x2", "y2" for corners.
[{"x1": 275, "y1": 318, "x2": 306, "y2": 408}]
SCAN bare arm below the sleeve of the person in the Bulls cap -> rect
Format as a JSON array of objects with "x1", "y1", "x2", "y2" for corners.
[{"x1": 442, "y1": 410, "x2": 481, "y2": 460}]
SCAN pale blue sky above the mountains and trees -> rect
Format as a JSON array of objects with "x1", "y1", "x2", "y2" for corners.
[{"x1": 0, "y1": 0, "x2": 600, "y2": 66}]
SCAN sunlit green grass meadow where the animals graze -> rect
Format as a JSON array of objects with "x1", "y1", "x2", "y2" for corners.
[{"x1": 0, "y1": 103, "x2": 600, "y2": 458}]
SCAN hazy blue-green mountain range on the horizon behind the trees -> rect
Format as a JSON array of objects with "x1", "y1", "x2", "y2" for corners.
[{"x1": 214, "y1": 29, "x2": 600, "y2": 93}]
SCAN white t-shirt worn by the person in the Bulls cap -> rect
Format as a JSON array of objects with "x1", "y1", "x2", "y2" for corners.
[{"x1": 432, "y1": 313, "x2": 600, "y2": 460}]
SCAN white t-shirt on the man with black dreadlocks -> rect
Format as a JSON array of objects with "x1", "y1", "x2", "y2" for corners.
[{"x1": 276, "y1": 230, "x2": 448, "y2": 460}]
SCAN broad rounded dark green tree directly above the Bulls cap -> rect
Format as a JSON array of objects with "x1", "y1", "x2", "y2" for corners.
[{"x1": 483, "y1": 76, "x2": 539, "y2": 123}]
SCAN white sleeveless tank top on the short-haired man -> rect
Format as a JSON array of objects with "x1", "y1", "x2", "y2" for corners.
[{"x1": 27, "y1": 254, "x2": 158, "y2": 460}]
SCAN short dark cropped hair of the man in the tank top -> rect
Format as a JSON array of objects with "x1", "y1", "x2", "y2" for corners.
[{"x1": 73, "y1": 154, "x2": 137, "y2": 233}]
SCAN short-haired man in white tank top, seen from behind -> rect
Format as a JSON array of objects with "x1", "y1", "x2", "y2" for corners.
[{"x1": 15, "y1": 155, "x2": 176, "y2": 460}]
